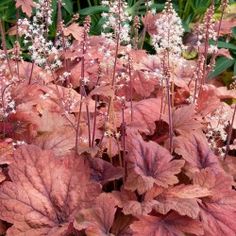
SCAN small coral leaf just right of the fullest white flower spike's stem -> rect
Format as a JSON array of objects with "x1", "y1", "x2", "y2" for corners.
[{"x1": 173, "y1": 105, "x2": 202, "y2": 135}]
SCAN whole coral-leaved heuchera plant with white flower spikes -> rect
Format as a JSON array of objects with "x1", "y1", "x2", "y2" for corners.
[{"x1": 0, "y1": 0, "x2": 236, "y2": 236}]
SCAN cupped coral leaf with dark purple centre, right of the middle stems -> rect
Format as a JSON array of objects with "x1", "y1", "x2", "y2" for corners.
[{"x1": 125, "y1": 133, "x2": 184, "y2": 194}]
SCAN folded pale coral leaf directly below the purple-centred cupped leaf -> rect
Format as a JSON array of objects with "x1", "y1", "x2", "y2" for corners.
[{"x1": 154, "y1": 185, "x2": 211, "y2": 219}]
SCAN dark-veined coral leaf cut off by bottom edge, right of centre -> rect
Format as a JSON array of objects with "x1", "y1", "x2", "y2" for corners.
[{"x1": 130, "y1": 213, "x2": 203, "y2": 236}]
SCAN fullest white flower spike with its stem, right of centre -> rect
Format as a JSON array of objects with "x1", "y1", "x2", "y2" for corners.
[{"x1": 152, "y1": 0, "x2": 184, "y2": 152}]
